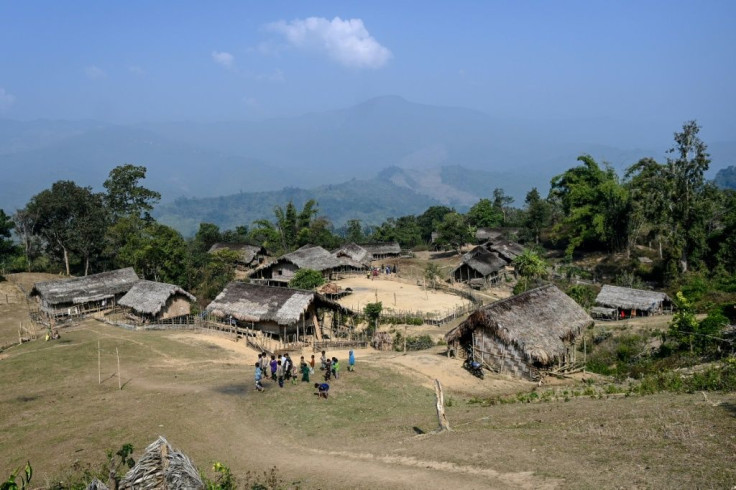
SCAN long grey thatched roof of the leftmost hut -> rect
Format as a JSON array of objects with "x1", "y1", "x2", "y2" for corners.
[{"x1": 31, "y1": 267, "x2": 139, "y2": 305}]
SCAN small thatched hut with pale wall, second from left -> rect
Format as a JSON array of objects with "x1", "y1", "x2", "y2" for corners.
[{"x1": 118, "y1": 280, "x2": 197, "y2": 323}]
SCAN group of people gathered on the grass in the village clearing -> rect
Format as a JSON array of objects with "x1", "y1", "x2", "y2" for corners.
[{"x1": 254, "y1": 351, "x2": 355, "y2": 399}]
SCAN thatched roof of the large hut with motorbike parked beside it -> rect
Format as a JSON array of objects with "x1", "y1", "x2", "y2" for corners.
[{"x1": 445, "y1": 284, "x2": 593, "y2": 365}]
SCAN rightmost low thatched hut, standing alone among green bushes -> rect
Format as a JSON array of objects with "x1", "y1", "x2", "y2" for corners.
[{"x1": 595, "y1": 284, "x2": 672, "y2": 319}]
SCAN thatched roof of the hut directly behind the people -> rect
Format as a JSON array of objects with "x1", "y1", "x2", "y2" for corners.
[{"x1": 207, "y1": 281, "x2": 342, "y2": 326}]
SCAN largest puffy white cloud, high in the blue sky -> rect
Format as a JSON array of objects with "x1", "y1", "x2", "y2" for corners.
[{"x1": 267, "y1": 17, "x2": 391, "y2": 68}]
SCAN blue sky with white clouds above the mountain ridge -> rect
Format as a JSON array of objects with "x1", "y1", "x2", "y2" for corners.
[{"x1": 0, "y1": 0, "x2": 736, "y2": 139}]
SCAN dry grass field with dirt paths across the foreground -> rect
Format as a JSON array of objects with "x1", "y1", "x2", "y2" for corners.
[{"x1": 0, "y1": 274, "x2": 736, "y2": 489}]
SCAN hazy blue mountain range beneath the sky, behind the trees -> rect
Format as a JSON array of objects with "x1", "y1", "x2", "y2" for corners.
[{"x1": 0, "y1": 96, "x2": 736, "y2": 233}]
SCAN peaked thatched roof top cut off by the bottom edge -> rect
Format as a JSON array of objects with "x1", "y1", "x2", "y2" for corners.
[{"x1": 118, "y1": 436, "x2": 204, "y2": 490}]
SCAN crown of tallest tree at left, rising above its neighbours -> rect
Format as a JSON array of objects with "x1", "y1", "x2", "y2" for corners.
[{"x1": 102, "y1": 164, "x2": 161, "y2": 218}]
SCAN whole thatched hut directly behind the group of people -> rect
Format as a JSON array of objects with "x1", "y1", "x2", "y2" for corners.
[{"x1": 206, "y1": 281, "x2": 348, "y2": 340}]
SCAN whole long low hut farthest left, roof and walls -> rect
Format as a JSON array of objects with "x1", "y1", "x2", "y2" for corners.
[{"x1": 30, "y1": 267, "x2": 140, "y2": 318}]
